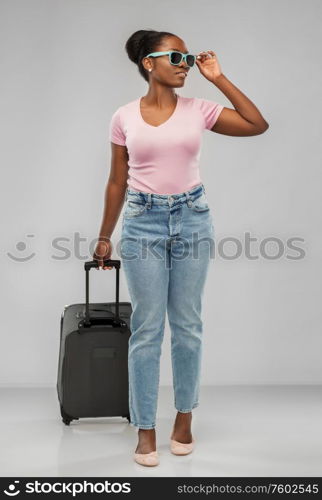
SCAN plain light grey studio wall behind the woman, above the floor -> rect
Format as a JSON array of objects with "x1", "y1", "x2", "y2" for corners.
[{"x1": 0, "y1": 0, "x2": 322, "y2": 386}]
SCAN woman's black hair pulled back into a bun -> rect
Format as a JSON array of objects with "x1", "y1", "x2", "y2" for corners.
[{"x1": 125, "y1": 30, "x2": 176, "y2": 82}]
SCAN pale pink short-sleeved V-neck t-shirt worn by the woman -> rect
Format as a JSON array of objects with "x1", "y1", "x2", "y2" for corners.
[{"x1": 109, "y1": 94, "x2": 224, "y2": 194}]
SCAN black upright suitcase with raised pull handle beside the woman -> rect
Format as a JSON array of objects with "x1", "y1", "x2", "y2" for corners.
[{"x1": 56, "y1": 259, "x2": 132, "y2": 425}]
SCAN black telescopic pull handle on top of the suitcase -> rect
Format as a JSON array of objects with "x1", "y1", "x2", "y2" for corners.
[{"x1": 79, "y1": 259, "x2": 126, "y2": 327}]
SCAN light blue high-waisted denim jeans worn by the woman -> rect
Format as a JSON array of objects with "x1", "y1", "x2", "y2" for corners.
[{"x1": 120, "y1": 184, "x2": 214, "y2": 429}]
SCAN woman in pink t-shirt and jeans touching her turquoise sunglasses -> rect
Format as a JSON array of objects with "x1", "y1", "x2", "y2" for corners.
[{"x1": 93, "y1": 30, "x2": 268, "y2": 466}]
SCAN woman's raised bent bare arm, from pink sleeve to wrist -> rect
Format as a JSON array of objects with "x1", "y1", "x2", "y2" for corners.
[{"x1": 211, "y1": 73, "x2": 269, "y2": 136}]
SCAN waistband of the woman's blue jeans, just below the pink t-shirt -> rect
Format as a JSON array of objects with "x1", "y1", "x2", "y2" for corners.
[{"x1": 125, "y1": 183, "x2": 206, "y2": 206}]
